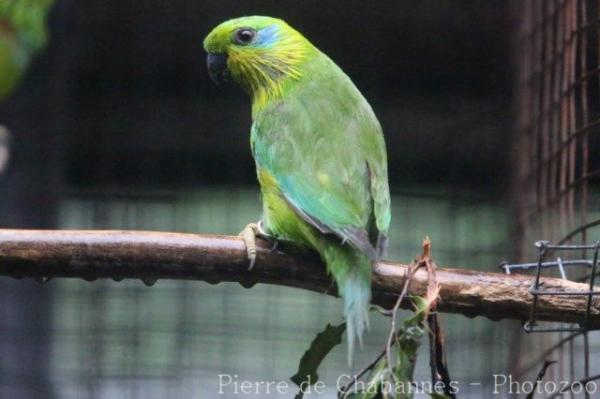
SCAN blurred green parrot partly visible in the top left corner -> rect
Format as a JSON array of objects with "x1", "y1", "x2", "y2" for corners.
[{"x1": 0, "y1": 0, "x2": 53, "y2": 102}]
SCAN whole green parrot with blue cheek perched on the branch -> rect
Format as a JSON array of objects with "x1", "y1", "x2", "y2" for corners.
[{"x1": 204, "y1": 16, "x2": 391, "y2": 364}]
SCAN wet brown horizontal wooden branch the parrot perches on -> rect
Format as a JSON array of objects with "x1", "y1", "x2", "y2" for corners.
[{"x1": 0, "y1": 229, "x2": 600, "y2": 328}]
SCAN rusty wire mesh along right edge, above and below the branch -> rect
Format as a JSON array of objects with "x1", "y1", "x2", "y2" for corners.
[{"x1": 512, "y1": 0, "x2": 600, "y2": 397}]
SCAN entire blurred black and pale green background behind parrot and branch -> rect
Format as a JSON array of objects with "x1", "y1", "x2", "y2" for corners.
[{"x1": 0, "y1": 0, "x2": 600, "y2": 398}]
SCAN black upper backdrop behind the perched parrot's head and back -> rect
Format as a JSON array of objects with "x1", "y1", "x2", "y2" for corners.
[{"x1": 0, "y1": 0, "x2": 511, "y2": 194}]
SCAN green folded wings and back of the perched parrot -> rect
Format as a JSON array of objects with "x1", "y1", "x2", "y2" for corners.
[{"x1": 252, "y1": 58, "x2": 390, "y2": 259}]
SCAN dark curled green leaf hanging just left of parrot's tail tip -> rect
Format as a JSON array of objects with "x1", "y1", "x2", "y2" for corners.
[{"x1": 290, "y1": 323, "x2": 346, "y2": 390}]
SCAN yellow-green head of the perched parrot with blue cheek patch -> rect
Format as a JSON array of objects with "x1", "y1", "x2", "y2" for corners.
[{"x1": 204, "y1": 16, "x2": 314, "y2": 103}]
